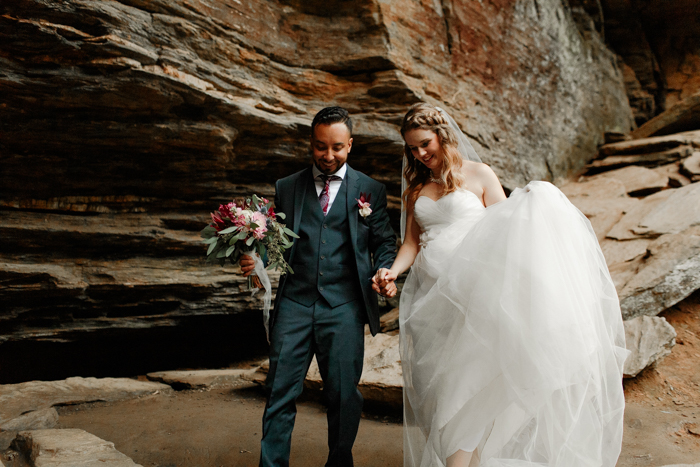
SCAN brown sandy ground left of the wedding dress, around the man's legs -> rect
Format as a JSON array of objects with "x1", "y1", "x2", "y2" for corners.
[{"x1": 52, "y1": 388, "x2": 403, "y2": 467}]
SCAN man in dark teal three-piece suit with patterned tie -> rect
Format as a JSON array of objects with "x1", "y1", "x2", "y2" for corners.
[{"x1": 240, "y1": 107, "x2": 396, "y2": 467}]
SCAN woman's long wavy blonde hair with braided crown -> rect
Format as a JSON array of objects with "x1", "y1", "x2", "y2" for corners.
[{"x1": 401, "y1": 102, "x2": 464, "y2": 210}]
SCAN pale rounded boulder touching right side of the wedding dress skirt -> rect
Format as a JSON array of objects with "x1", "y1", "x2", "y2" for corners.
[{"x1": 623, "y1": 316, "x2": 676, "y2": 378}]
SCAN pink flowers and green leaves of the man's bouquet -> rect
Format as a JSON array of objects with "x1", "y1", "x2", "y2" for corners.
[{"x1": 202, "y1": 195, "x2": 299, "y2": 273}]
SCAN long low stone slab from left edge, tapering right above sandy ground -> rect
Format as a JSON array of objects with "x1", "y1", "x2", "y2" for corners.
[{"x1": 0, "y1": 377, "x2": 172, "y2": 425}]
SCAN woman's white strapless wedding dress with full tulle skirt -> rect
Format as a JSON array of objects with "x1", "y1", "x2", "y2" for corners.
[{"x1": 400, "y1": 182, "x2": 628, "y2": 467}]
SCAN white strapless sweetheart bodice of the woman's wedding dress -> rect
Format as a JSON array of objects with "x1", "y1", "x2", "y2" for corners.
[{"x1": 413, "y1": 190, "x2": 486, "y2": 245}]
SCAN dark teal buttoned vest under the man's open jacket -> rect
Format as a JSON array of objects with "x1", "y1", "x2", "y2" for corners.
[{"x1": 283, "y1": 177, "x2": 362, "y2": 307}]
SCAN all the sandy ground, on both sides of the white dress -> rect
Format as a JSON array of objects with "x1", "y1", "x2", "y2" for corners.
[{"x1": 5, "y1": 294, "x2": 700, "y2": 467}]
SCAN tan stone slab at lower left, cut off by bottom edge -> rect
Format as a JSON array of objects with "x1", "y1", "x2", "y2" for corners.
[{"x1": 12, "y1": 428, "x2": 141, "y2": 467}]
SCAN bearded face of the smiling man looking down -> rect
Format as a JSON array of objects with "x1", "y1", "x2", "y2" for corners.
[{"x1": 311, "y1": 123, "x2": 352, "y2": 175}]
